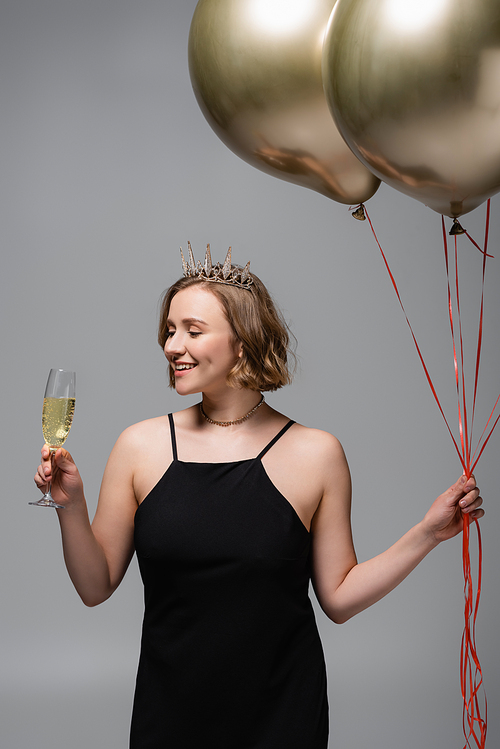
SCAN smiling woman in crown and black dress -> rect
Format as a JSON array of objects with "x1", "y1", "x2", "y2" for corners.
[{"x1": 35, "y1": 247, "x2": 484, "y2": 749}]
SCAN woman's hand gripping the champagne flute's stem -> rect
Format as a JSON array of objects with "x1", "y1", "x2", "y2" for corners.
[{"x1": 35, "y1": 445, "x2": 84, "y2": 507}]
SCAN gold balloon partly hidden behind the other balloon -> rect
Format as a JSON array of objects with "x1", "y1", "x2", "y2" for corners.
[{"x1": 189, "y1": 0, "x2": 380, "y2": 203}]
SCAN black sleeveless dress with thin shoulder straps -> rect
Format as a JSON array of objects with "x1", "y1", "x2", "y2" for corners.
[{"x1": 130, "y1": 414, "x2": 328, "y2": 749}]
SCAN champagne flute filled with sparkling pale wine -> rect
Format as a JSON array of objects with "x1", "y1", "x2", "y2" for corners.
[{"x1": 28, "y1": 369, "x2": 76, "y2": 509}]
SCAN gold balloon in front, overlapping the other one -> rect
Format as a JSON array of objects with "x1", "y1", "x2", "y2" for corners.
[{"x1": 323, "y1": 0, "x2": 500, "y2": 217}]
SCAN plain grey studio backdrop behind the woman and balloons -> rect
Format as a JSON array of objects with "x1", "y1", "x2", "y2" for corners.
[{"x1": 0, "y1": 0, "x2": 500, "y2": 749}]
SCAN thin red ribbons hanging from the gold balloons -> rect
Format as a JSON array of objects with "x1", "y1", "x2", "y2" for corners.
[{"x1": 363, "y1": 200, "x2": 494, "y2": 749}]
